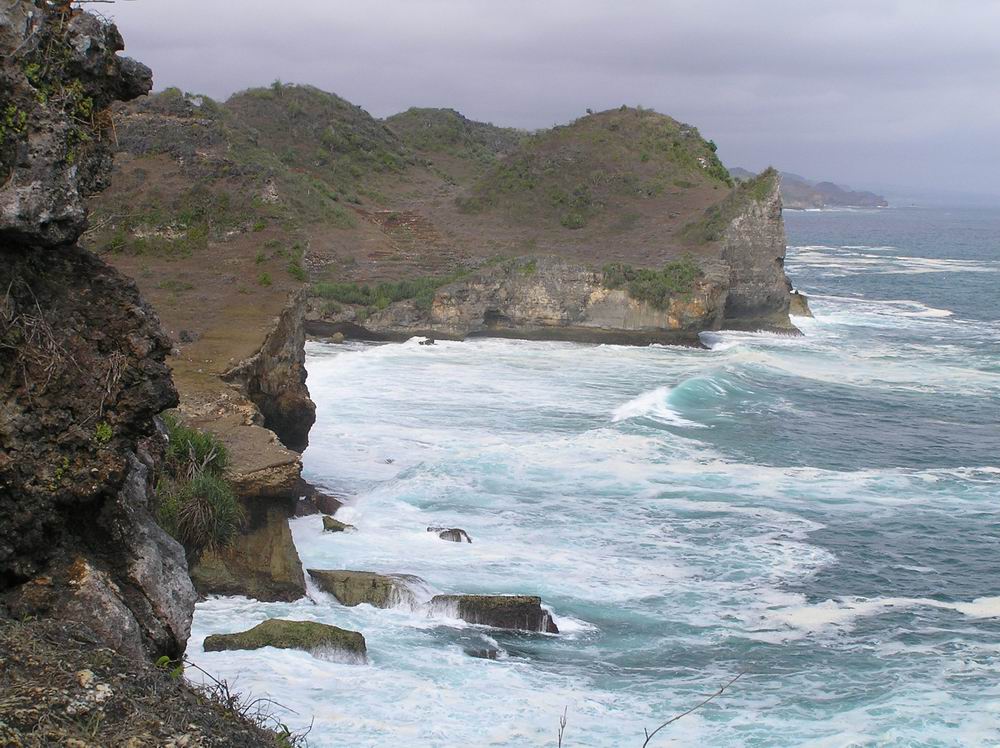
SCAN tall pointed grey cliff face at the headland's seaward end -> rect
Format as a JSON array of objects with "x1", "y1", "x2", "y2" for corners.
[{"x1": 722, "y1": 169, "x2": 795, "y2": 331}]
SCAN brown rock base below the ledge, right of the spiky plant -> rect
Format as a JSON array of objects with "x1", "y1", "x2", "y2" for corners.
[{"x1": 191, "y1": 500, "x2": 306, "y2": 601}]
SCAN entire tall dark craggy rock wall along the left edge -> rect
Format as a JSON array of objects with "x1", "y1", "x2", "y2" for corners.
[{"x1": 0, "y1": 1, "x2": 195, "y2": 656}]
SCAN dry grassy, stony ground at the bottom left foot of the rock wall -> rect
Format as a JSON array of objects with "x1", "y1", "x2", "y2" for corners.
[{"x1": 0, "y1": 618, "x2": 290, "y2": 748}]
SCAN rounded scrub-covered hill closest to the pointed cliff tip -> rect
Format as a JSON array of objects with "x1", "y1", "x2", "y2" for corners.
[{"x1": 458, "y1": 107, "x2": 733, "y2": 229}]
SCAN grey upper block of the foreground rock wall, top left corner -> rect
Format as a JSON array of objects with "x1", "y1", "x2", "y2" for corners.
[{"x1": 0, "y1": 0, "x2": 152, "y2": 247}]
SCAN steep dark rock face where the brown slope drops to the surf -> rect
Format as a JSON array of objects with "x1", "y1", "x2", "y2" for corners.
[{"x1": 223, "y1": 291, "x2": 316, "y2": 452}]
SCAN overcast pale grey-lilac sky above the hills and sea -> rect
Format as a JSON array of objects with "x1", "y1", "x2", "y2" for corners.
[{"x1": 105, "y1": 0, "x2": 1000, "y2": 199}]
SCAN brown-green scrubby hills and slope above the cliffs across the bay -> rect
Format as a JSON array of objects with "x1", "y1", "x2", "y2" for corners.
[{"x1": 87, "y1": 82, "x2": 772, "y2": 382}]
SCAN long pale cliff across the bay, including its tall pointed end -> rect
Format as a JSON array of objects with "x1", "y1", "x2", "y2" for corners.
[{"x1": 307, "y1": 171, "x2": 796, "y2": 345}]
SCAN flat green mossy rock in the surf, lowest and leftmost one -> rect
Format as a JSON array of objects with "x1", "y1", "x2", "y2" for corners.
[{"x1": 205, "y1": 618, "x2": 367, "y2": 660}]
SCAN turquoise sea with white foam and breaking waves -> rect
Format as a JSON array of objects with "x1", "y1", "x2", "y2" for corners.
[{"x1": 190, "y1": 209, "x2": 1000, "y2": 746}]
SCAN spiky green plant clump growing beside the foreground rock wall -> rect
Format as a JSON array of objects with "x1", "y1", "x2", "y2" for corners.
[{"x1": 156, "y1": 413, "x2": 246, "y2": 555}]
